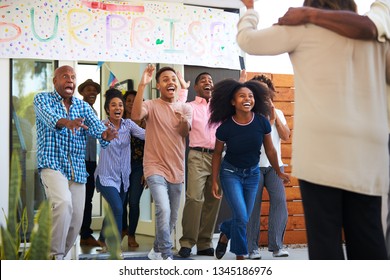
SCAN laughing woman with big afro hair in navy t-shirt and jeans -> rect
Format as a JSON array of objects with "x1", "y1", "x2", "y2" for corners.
[{"x1": 209, "y1": 79, "x2": 289, "y2": 260}]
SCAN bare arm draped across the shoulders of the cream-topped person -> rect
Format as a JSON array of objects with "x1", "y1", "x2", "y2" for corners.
[{"x1": 278, "y1": 7, "x2": 378, "y2": 40}]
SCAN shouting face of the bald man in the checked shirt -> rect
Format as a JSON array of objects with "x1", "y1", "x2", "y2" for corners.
[{"x1": 53, "y1": 66, "x2": 76, "y2": 100}]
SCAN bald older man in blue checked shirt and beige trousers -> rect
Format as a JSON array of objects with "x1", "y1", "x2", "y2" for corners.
[{"x1": 34, "y1": 66, "x2": 118, "y2": 259}]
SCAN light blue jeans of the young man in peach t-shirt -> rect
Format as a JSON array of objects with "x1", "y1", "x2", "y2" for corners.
[{"x1": 146, "y1": 175, "x2": 183, "y2": 259}]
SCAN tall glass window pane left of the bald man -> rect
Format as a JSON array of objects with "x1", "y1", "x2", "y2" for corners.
[{"x1": 10, "y1": 59, "x2": 54, "y2": 238}]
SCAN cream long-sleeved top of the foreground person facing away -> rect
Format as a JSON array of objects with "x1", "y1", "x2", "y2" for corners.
[{"x1": 238, "y1": 8, "x2": 390, "y2": 195}]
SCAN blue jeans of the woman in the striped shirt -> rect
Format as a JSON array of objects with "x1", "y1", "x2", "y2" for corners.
[{"x1": 96, "y1": 176, "x2": 125, "y2": 241}]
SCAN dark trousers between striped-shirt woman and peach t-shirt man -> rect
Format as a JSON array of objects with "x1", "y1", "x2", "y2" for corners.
[{"x1": 122, "y1": 161, "x2": 144, "y2": 235}]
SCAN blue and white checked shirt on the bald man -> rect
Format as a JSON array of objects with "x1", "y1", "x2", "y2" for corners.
[{"x1": 34, "y1": 90, "x2": 109, "y2": 184}]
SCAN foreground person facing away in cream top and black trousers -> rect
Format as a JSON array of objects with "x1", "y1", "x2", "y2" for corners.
[{"x1": 237, "y1": 0, "x2": 390, "y2": 259}]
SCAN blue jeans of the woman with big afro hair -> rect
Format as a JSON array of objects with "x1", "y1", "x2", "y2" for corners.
[{"x1": 219, "y1": 160, "x2": 260, "y2": 256}]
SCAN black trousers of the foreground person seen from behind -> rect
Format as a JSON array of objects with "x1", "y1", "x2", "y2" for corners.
[{"x1": 299, "y1": 180, "x2": 387, "y2": 260}]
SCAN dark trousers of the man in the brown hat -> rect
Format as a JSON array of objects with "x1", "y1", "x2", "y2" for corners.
[{"x1": 80, "y1": 161, "x2": 96, "y2": 239}]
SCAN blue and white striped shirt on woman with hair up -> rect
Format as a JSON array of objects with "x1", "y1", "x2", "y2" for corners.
[{"x1": 95, "y1": 119, "x2": 145, "y2": 192}]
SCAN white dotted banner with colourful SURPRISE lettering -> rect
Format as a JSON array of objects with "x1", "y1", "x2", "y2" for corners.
[{"x1": 0, "y1": 0, "x2": 240, "y2": 69}]
